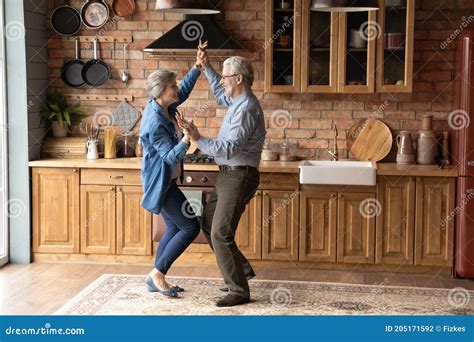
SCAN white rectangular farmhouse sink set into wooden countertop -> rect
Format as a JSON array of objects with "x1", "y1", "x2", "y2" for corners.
[{"x1": 300, "y1": 160, "x2": 377, "y2": 185}]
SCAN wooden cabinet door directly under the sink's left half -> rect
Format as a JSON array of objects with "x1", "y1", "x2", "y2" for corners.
[{"x1": 300, "y1": 191, "x2": 337, "y2": 262}]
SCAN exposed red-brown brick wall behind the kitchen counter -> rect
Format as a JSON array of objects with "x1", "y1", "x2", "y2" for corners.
[{"x1": 48, "y1": 0, "x2": 474, "y2": 158}]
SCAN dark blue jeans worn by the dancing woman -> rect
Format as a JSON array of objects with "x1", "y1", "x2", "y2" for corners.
[{"x1": 155, "y1": 181, "x2": 200, "y2": 274}]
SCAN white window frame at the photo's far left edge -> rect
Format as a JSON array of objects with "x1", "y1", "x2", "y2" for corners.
[{"x1": 0, "y1": 1, "x2": 9, "y2": 266}]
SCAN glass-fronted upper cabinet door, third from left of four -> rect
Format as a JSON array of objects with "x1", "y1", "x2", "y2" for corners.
[{"x1": 338, "y1": 11, "x2": 379, "y2": 93}]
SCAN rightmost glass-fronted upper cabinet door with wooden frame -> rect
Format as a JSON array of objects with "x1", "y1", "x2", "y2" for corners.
[{"x1": 376, "y1": 0, "x2": 415, "y2": 93}]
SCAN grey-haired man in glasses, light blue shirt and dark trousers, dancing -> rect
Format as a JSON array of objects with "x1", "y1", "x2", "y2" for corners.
[{"x1": 181, "y1": 49, "x2": 266, "y2": 307}]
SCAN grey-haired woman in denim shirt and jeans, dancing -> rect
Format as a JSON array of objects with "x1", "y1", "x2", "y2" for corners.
[{"x1": 140, "y1": 41, "x2": 205, "y2": 297}]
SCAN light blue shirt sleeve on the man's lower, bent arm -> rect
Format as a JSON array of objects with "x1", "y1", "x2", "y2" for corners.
[{"x1": 197, "y1": 111, "x2": 257, "y2": 159}]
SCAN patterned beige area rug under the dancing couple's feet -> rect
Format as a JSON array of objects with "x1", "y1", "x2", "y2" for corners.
[{"x1": 56, "y1": 274, "x2": 474, "y2": 315}]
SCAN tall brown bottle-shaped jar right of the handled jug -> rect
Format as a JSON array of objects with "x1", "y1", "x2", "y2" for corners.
[{"x1": 416, "y1": 115, "x2": 437, "y2": 165}]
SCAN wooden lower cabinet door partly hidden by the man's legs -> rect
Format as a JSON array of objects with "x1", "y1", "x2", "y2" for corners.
[{"x1": 235, "y1": 190, "x2": 262, "y2": 259}]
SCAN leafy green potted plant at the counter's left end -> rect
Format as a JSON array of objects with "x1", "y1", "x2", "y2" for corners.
[{"x1": 41, "y1": 92, "x2": 85, "y2": 137}]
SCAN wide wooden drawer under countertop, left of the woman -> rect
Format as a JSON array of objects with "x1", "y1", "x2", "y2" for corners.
[{"x1": 81, "y1": 169, "x2": 142, "y2": 186}]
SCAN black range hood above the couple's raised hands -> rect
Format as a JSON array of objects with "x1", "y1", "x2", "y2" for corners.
[{"x1": 143, "y1": 14, "x2": 243, "y2": 56}]
